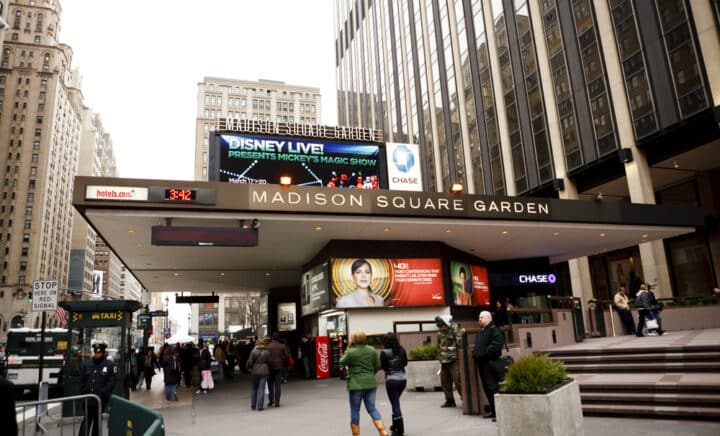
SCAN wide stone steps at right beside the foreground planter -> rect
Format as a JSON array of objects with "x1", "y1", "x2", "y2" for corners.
[{"x1": 549, "y1": 344, "x2": 720, "y2": 421}]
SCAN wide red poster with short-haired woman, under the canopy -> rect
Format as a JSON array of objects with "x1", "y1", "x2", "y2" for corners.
[{"x1": 330, "y1": 258, "x2": 445, "y2": 309}]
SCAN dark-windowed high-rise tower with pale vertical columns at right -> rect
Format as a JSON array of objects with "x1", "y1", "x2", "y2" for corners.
[{"x1": 334, "y1": 0, "x2": 720, "y2": 301}]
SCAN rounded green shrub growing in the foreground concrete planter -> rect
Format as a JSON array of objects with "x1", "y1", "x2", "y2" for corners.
[{"x1": 502, "y1": 354, "x2": 568, "y2": 394}]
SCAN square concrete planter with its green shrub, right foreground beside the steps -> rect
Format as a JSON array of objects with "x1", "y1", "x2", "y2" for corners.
[{"x1": 495, "y1": 354, "x2": 584, "y2": 436}]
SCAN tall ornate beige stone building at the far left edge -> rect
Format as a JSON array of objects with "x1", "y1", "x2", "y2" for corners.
[{"x1": 0, "y1": 0, "x2": 82, "y2": 336}]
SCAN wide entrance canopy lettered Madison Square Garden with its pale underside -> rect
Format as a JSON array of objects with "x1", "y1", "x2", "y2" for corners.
[{"x1": 73, "y1": 177, "x2": 704, "y2": 293}]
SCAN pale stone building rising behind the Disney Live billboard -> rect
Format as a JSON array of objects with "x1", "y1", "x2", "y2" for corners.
[{"x1": 195, "y1": 77, "x2": 322, "y2": 180}]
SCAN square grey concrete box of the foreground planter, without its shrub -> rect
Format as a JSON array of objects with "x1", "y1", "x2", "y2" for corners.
[{"x1": 495, "y1": 381, "x2": 585, "y2": 436}]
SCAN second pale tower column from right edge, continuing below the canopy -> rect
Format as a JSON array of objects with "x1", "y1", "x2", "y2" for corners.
[{"x1": 593, "y1": 1, "x2": 672, "y2": 297}]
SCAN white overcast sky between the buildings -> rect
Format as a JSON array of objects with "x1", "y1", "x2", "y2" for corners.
[{"x1": 60, "y1": 0, "x2": 337, "y2": 180}]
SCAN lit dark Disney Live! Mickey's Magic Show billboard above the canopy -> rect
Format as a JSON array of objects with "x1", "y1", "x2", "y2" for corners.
[{"x1": 218, "y1": 134, "x2": 380, "y2": 189}]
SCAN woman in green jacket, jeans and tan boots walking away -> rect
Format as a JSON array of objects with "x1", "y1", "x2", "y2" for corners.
[{"x1": 340, "y1": 330, "x2": 388, "y2": 436}]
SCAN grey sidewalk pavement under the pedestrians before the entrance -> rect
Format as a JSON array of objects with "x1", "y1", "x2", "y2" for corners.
[{"x1": 130, "y1": 374, "x2": 720, "y2": 436}]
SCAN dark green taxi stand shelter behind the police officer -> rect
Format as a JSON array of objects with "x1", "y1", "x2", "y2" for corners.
[{"x1": 60, "y1": 300, "x2": 142, "y2": 416}]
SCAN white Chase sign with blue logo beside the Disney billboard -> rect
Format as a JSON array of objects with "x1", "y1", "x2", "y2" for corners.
[{"x1": 385, "y1": 142, "x2": 422, "y2": 192}]
